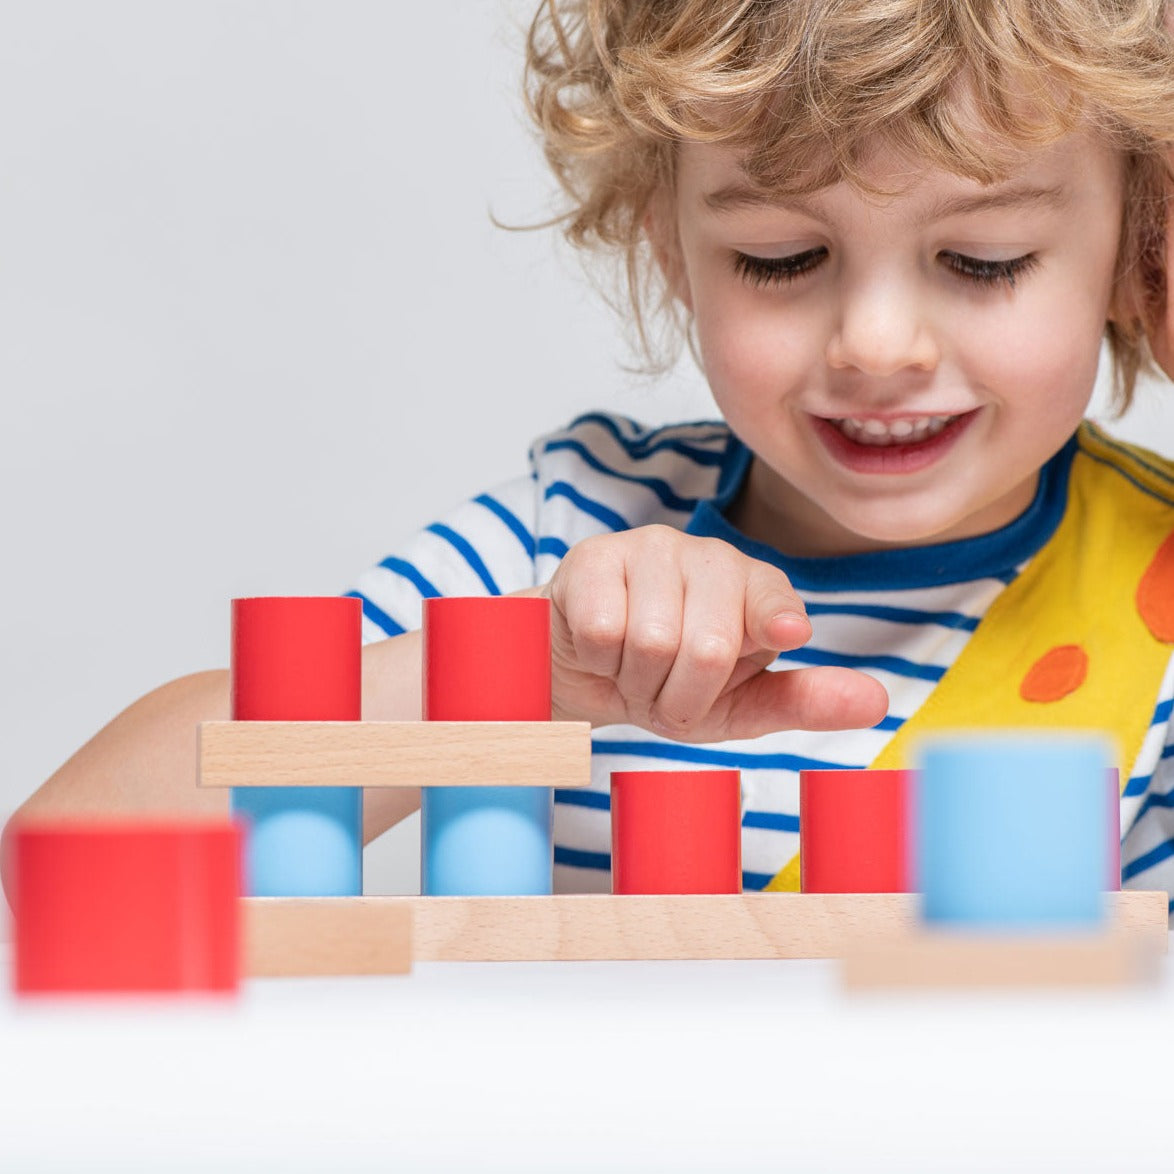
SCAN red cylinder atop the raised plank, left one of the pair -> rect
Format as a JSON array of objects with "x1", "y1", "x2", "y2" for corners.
[{"x1": 232, "y1": 595, "x2": 363, "y2": 722}]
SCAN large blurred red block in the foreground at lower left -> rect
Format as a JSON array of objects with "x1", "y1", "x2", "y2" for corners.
[{"x1": 8, "y1": 821, "x2": 241, "y2": 993}]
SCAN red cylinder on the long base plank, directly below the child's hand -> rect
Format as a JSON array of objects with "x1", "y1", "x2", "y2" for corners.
[{"x1": 612, "y1": 770, "x2": 742, "y2": 893}]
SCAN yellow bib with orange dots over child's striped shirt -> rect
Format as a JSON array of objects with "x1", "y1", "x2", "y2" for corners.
[{"x1": 767, "y1": 421, "x2": 1174, "y2": 892}]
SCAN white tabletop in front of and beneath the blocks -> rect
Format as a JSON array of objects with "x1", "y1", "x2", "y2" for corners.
[{"x1": 0, "y1": 947, "x2": 1174, "y2": 1174}]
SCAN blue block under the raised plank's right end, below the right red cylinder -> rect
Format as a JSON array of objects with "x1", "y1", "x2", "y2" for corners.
[{"x1": 420, "y1": 787, "x2": 554, "y2": 897}]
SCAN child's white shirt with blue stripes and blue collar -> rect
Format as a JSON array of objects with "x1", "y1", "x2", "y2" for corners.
[{"x1": 353, "y1": 413, "x2": 1174, "y2": 893}]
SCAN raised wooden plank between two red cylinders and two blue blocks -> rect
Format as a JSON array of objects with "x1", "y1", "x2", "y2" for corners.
[{"x1": 198, "y1": 722, "x2": 591, "y2": 788}]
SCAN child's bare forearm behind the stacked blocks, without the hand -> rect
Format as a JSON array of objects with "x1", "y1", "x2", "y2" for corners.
[{"x1": 0, "y1": 633, "x2": 420, "y2": 906}]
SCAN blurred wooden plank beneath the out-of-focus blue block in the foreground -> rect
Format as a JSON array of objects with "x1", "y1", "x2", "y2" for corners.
[{"x1": 842, "y1": 925, "x2": 1160, "y2": 991}]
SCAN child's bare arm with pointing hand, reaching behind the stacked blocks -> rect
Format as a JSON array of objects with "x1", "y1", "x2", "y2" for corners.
[{"x1": 0, "y1": 526, "x2": 888, "y2": 906}]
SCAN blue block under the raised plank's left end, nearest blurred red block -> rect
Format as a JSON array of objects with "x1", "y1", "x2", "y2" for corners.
[{"x1": 232, "y1": 787, "x2": 363, "y2": 897}]
